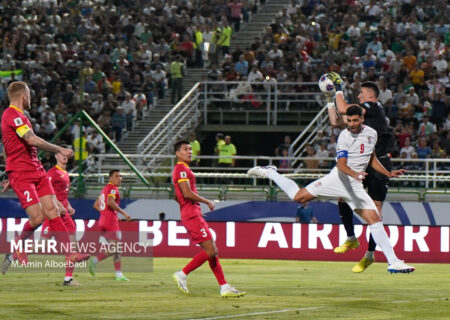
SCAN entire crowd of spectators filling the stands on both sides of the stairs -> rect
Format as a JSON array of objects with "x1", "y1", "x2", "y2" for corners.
[{"x1": 0, "y1": 0, "x2": 450, "y2": 172}]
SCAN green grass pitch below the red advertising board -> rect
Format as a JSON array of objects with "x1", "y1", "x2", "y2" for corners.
[{"x1": 0, "y1": 258, "x2": 450, "y2": 320}]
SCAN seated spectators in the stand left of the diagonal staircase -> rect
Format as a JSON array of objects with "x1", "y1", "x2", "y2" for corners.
[{"x1": 0, "y1": 0, "x2": 259, "y2": 169}]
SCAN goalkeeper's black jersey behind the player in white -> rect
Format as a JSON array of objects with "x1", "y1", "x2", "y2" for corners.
[{"x1": 360, "y1": 102, "x2": 395, "y2": 157}]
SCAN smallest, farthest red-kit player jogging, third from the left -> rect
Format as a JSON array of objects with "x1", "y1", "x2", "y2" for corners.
[{"x1": 89, "y1": 170, "x2": 131, "y2": 281}]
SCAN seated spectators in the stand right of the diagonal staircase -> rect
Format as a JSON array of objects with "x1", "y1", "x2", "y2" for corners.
[{"x1": 217, "y1": 0, "x2": 450, "y2": 165}]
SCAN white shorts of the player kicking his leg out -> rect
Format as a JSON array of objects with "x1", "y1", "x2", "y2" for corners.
[{"x1": 306, "y1": 167, "x2": 377, "y2": 211}]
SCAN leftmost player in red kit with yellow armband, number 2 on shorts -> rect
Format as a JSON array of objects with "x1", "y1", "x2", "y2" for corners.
[{"x1": 1, "y1": 81, "x2": 89, "y2": 272}]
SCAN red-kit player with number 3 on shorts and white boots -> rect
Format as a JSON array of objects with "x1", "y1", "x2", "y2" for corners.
[{"x1": 172, "y1": 141, "x2": 246, "y2": 297}]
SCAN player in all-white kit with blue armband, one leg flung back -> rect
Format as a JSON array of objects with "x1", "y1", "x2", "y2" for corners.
[{"x1": 247, "y1": 105, "x2": 415, "y2": 273}]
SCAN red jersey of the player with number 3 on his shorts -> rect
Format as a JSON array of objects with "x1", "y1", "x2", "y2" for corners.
[{"x1": 172, "y1": 162, "x2": 202, "y2": 220}]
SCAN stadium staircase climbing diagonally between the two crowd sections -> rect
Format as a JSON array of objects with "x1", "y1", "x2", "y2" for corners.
[{"x1": 102, "y1": 0, "x2": 289, "y2": 178}]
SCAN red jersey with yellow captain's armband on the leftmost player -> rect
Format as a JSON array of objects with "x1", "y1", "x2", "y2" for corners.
[{"x1": 2, "y1": 105, "x2": 43, "y2": 172}]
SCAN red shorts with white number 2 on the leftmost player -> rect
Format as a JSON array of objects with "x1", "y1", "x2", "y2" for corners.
[{"x1": 8, "y1": 169, "x2": 55, "y2": 209}]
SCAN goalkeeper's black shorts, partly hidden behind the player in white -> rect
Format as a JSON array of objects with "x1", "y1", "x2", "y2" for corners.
[{"x1": 363, "y1": 156, "x2": 392, "y2": 201}]
